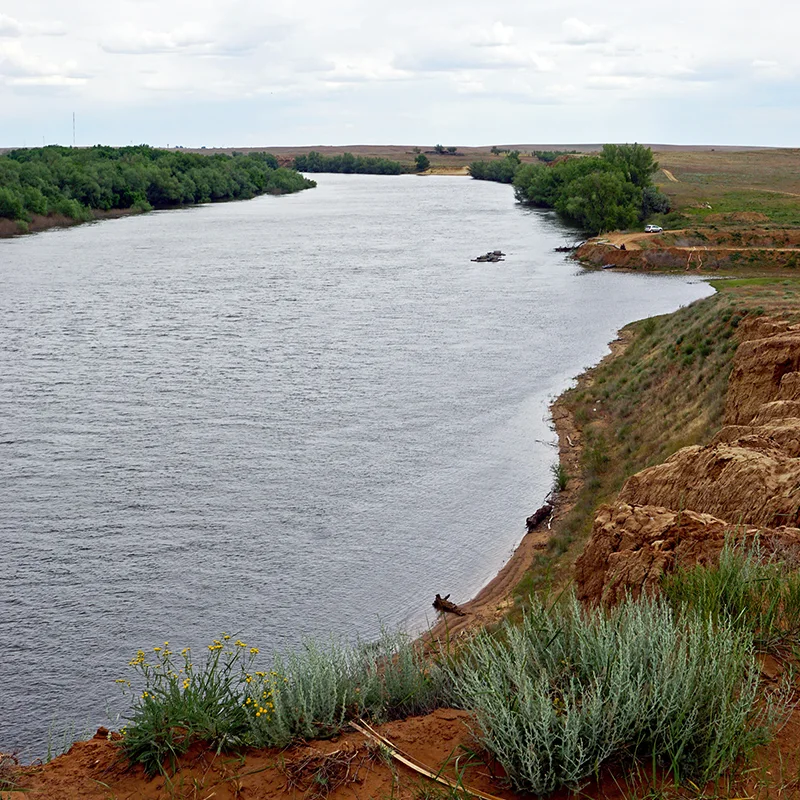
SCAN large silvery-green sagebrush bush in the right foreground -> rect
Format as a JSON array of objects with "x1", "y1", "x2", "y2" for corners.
[{"x1": 446, "y1": 597, "x2": 769, "y2": 795}]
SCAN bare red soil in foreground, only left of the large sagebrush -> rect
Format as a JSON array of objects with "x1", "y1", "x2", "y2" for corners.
[{"x1": 6, "y1": 709, "x2": 517, "y2": 800}]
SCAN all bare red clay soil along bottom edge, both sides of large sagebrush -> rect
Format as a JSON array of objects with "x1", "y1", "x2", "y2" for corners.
[{"x1": 9, "y1": 708, "x2": 800, "y2": 800}]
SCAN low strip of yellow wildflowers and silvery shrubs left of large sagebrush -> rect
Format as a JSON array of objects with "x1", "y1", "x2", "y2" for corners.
[{"x1": 121, "y1": 633, "x2": 454, "y2": 774}]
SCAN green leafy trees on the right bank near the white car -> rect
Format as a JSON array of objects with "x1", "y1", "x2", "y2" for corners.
[{"x1": 470, "y1": 144, "x2": 670, "y2": 233}]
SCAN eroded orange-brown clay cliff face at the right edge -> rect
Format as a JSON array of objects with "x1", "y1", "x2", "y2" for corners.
[{"x1": 576, "y1": 319, "x2": 800, "y2": 603}]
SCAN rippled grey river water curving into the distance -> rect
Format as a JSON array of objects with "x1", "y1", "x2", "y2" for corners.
[{"x1": 0, "y1": 175, "x2": 710, "y2": 758}]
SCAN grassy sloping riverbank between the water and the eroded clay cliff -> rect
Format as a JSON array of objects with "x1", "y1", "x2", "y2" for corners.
[{"x1": 432, "y1": 277, "x2": 800, "y2": 639}]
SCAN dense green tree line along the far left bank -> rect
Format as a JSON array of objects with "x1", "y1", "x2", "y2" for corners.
[{"x1": 0, "y1": 145, "x2": 316, "y2": 223}]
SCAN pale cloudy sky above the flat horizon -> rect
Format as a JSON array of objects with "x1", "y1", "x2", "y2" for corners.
[{"x1": 0, "y1": 0, "x2": 800, "y2": 147}]
